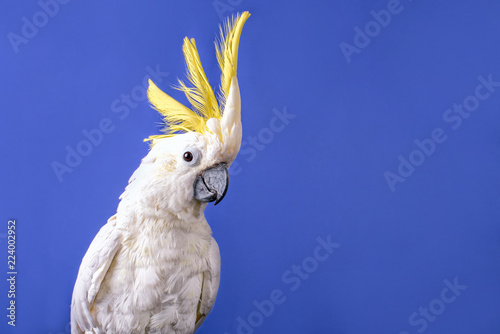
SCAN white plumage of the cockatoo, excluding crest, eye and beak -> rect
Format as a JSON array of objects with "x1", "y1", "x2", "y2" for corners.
[{"x1": 71, "y1": 133, "x2": 221, "y2": 334}]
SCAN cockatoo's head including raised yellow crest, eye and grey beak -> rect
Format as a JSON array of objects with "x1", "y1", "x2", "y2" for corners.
[{"x1": 140, "y1": 12, "x2": 250, "y2": 214}]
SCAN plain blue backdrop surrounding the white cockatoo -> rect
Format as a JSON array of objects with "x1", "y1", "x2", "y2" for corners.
[{"x1": 0, "y1": 0, "x2": 500, "y2": 334}]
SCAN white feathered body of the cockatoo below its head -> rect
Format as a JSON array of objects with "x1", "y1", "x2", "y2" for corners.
[{"x1": 72, "y1": 135, "x2": 220, "y2": 334}]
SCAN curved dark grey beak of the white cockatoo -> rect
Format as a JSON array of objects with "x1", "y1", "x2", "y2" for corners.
[{"x1": 194, "y1": 163, "x2": 229, "y2": 205}]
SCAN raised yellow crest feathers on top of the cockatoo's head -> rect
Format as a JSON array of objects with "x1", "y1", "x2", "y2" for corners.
[{"x1": 145, "y1": 12, "x2": 250, "y2": 141}]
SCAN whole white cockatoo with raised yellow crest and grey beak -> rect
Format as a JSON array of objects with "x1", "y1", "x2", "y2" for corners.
[{"x1": 71, "y1": 12, "x2": 250, "y2": 334}]
